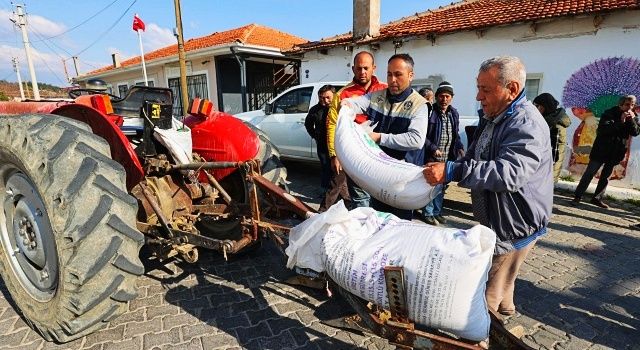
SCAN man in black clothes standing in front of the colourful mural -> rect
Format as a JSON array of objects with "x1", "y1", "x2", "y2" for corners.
[{"x1": 571, "y1": 95, "x2": 640, "y2": 208}]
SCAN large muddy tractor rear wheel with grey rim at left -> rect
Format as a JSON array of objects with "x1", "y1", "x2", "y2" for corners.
[{"x1": 0, "y1": 115, "x2": 144, "y2": 342}]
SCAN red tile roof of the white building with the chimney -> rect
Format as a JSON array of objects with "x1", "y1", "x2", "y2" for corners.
[{"x1": 290, "y1": 0, "x2": 640, "y2": 51}]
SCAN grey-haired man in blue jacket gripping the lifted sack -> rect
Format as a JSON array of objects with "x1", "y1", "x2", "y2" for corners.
[{"x1": 424, "y1": 56, "x2": 553, "y2": 315}]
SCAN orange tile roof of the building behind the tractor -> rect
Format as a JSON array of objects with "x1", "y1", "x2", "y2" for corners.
[{"x1": 85, "y1": 24, "x2": 307, "y2": 75}]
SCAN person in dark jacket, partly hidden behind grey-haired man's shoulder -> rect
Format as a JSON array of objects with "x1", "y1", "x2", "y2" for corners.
[{"x1": 533, "y1": 92, "x2": 571, "y2": 182}]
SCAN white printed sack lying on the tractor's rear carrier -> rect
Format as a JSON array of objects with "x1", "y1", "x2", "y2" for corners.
[{"x1": 286, "y1": 202, "x2": 496, "y2": 341}]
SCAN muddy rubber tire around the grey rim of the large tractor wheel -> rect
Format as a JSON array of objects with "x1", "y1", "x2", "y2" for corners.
[{"x1": 0, "y1": 114, "x2": 144, "y2": 343}]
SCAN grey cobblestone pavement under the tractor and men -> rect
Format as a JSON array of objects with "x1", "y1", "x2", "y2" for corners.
[{"x1": 0, "y1": 163, "x2": 640, "y2": 350}]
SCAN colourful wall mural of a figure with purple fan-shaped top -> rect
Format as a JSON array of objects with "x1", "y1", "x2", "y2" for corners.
[{"x1": 562, "y1": 57, "x2": 640, "y2": 179}]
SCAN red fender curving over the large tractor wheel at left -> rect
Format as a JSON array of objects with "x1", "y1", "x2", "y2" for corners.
[{"x1": 51, "y1": 104, "x2": 144, "y2": 191}]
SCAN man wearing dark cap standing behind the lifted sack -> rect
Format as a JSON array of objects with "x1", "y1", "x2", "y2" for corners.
[{"x1": 422, "y1": 81, "x2": 464, "y2": 225}]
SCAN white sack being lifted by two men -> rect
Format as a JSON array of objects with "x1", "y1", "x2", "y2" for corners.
[{"x1": 335, "y1": 106, "x2": 441, "y2": 209}]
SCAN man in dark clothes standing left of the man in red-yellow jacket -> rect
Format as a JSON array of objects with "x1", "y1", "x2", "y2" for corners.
[{"x1": 304, "y1": 85, "x2": 336, "y2": 191}]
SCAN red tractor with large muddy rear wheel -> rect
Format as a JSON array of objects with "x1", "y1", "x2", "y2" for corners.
[{"x1": 0, "y1": 86, "x2": 311, "y2": 342}]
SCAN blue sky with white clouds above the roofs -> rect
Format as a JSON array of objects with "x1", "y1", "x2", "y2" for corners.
[{"x1": 0, "y1": 0, "x2": 454, "y2": 86}]
